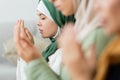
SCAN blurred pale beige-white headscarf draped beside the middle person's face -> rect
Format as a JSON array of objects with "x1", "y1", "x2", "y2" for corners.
[{"x1": 74, "y1": 0, "x2": 100, "y2": 41}]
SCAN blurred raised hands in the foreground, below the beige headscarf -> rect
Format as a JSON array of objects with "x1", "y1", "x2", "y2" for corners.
[{"x1": 58, "y1": 24, "x2": 96, "y2": 80}]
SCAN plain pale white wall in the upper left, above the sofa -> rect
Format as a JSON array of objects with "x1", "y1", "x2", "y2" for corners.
[{"x1": 0, "y1": 0, "x2": 38, "y2": 22}]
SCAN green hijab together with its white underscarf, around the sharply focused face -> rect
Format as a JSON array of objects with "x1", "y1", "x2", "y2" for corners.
[{"x1": 37, "y1": 0, "x2": 75, "y2": 61}]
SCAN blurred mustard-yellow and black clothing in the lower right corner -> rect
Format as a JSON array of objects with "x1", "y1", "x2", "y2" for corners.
[{"x1": 95, "y1": 37, "x2": 120, "y2": 80}]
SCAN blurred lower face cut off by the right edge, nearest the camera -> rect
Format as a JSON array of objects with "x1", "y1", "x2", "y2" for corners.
[{"x1": 95, "y1": 0, "x2": 120, "y2": 34}]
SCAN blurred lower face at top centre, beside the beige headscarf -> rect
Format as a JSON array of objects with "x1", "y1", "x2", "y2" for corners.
[{"x1": 49, "y1": 0, "x2": 75, "y2": 16}]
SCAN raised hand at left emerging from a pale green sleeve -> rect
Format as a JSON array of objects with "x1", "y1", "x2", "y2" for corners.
[{"x1": 14, "y1": 20, "x2": 41, "y2": 62}]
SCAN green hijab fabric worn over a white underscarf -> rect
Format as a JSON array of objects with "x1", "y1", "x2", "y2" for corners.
[{"x1": 39, "y1": 0, "x2": 75, "y2": 61}]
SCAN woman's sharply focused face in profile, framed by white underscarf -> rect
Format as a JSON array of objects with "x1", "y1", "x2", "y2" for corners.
[{"x1": 37, "y1": 11, "x2": 58, "y2": 38}]
